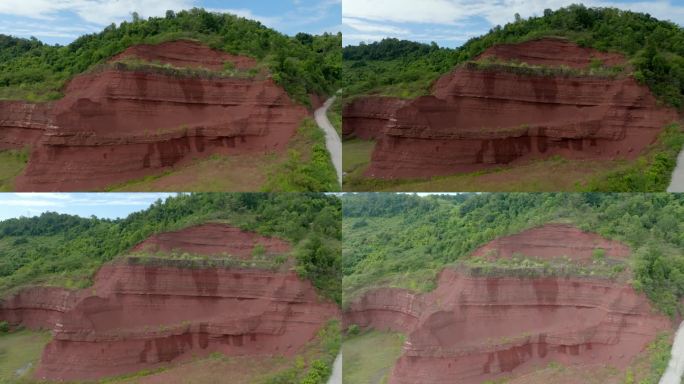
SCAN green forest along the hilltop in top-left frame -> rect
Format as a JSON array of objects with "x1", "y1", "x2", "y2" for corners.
[{"x1": 0, "y1": 8, "x2": 342, "y2": 104}]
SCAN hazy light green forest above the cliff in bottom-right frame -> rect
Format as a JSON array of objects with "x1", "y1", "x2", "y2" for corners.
[{"x1": 342, "y1": 193, "x2": 684, "y2": 314}]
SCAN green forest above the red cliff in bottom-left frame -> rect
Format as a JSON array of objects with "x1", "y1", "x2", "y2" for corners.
[{"x1": 0, "y1": 193, "x2": 342, "y2": 302}]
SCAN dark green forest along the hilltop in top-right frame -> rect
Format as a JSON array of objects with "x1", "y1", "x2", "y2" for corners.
[{"x1": 343, "y1": 4, "x2": 684, "y2": 108}]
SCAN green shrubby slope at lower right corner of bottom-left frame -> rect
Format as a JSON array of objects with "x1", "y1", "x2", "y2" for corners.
[{"x1": 264, "y1": 320, "x2": 342, "y2": 384}]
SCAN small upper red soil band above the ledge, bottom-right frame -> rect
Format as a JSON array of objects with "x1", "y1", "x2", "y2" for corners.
[{"x1": 473, "y1": 224, "x2": 630, "y2": 264}]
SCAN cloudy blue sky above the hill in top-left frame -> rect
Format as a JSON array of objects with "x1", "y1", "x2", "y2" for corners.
[{"x1": 0, "y1": 0, "x2": 342, "y2": 45}]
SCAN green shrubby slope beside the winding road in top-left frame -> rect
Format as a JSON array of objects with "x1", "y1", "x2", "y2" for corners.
[{"x1": 263, "y1": 118, "x2": 340, "y2": 192}]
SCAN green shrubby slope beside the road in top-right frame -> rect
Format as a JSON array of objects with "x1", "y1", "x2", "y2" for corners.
[{"x1": 580, "y1": 124, "x2": 684, "y2": 192}]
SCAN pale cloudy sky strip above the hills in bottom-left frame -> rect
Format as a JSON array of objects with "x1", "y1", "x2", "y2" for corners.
[{"x1": 0, "y1": 193, "x2": 175, "y2": 220}]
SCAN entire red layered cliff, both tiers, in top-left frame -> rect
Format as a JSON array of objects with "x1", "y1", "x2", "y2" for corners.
[{"x1": 0, "y1": 41, "x2": 308, "y2": 191}]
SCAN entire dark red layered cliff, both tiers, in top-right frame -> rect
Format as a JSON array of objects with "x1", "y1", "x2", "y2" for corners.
[{"x1": 343, "y1": 39, "x2": 677, "y2": 178}]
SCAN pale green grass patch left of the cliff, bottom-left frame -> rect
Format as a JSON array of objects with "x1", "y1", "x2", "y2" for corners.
[{"x1": 0, "y1": 330, "x2": 51, "y2": 383}]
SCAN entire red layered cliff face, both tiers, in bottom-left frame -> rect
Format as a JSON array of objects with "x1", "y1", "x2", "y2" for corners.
[{"x1": 0, "y1": 225, "x2": 339, "y2": 381}]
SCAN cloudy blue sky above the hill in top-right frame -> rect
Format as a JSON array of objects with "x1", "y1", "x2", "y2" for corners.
[{"x1": 342, "y1": 0, "x2": 684, "y2": 47}]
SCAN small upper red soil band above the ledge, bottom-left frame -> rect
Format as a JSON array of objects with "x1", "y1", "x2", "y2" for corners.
[{"x1": 133, "y1": 224, "x2": 291, "y2": 259}]
